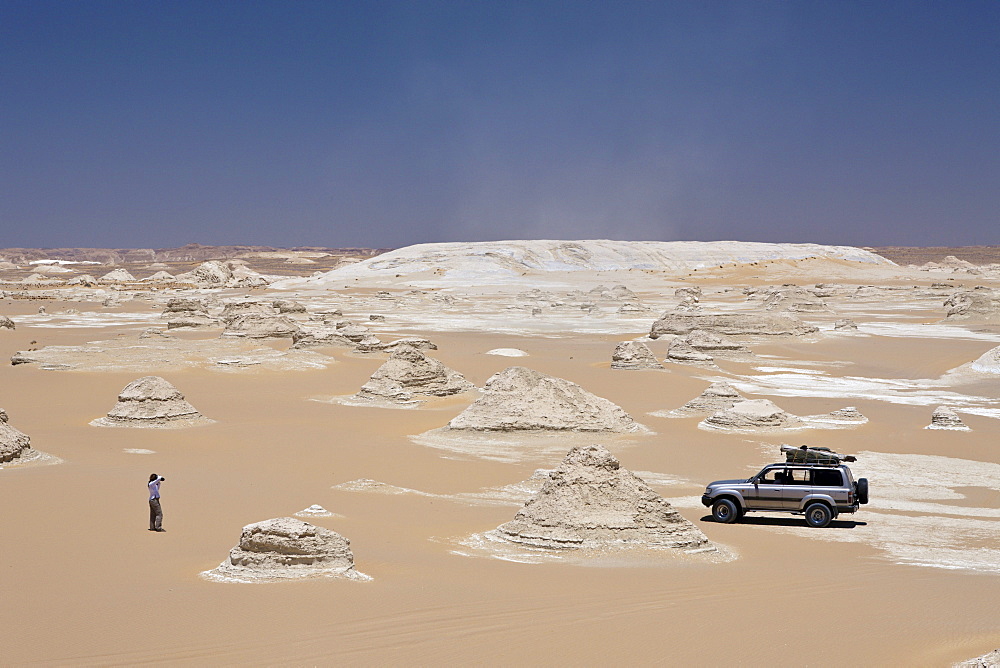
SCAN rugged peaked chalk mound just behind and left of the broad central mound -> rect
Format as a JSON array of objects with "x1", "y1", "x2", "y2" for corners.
[{"x1": 355, "y1": 345, "x2": 475, "y2": 403}]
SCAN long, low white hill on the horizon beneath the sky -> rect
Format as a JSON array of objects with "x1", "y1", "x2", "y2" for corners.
[{"x1": 273, "y1": 240, "x2": 895, "y2": 288}]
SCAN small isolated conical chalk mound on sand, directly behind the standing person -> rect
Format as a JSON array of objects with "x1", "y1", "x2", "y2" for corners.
[{"x1": 90, "y1": 376, "x2": 214, "y2": 428}]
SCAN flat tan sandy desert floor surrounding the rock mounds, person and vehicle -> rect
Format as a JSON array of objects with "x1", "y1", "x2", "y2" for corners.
[{"x1": 0, "y1": 258, "x2": 1000, "y2": 666}]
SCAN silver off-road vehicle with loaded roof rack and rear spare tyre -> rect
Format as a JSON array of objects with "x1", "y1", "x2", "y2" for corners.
[{"x1": 701, "y1": 445, "x2": 868, "y2": 527}]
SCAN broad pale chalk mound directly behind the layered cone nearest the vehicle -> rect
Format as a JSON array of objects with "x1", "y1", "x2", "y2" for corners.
[{"x1": 447, "y1": 366, "x2": 646, "y2": 433}]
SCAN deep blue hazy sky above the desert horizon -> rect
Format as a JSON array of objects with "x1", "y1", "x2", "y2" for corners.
[{"x1": 0, "y1": 0, "x2": 1000, "y2": 247}]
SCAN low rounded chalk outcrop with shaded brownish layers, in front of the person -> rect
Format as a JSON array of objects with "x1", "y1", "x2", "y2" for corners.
[{"x1": 202, "y1": 517, "x2": 371, "y2": 582}]
